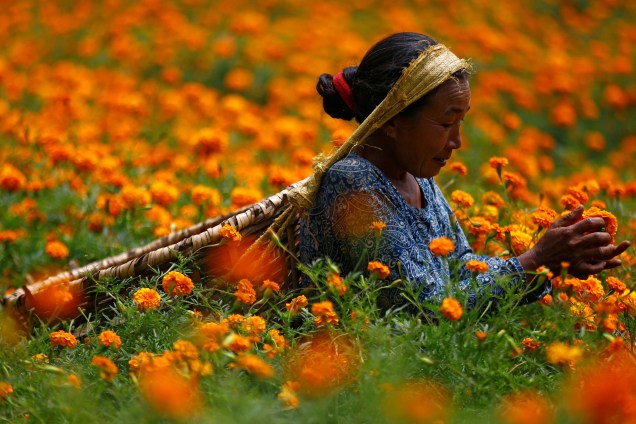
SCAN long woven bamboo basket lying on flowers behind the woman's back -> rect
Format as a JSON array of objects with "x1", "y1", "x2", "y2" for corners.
[{"x1": 2, "y1": 181, "x2": 303, "y2": 319}]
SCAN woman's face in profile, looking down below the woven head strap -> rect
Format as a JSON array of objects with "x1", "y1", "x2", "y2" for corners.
[{"x1": 389, "y1": 79, "x2": 470, "y2": 178}]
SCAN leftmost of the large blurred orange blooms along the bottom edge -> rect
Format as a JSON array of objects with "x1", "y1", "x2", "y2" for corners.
[{"x1": 139, "y1": 367, "x2": 202, "y2": 421}]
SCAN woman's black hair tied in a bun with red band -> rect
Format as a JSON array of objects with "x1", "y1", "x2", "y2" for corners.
[{"x1": 316, "y1": 32, "x2": 468, "y2": 122}]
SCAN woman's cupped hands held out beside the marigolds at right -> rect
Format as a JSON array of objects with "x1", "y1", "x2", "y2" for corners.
[{"x1": 519, "y1": 206, "x2": 631, "y2": 278}]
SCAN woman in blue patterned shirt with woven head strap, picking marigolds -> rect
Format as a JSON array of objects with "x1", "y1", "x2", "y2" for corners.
[{"x1": 300, "y1": 33, "x2": 629, "y2": 306}]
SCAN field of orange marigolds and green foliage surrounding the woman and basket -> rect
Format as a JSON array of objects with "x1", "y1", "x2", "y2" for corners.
[{"x1": 0, "y1": 0, "x2": 636, "y2": 423}]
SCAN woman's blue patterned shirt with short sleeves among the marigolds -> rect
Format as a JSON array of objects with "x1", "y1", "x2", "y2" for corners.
[{"x1": 300, "y1": 153, "x2": 543, "y2": 306}]
